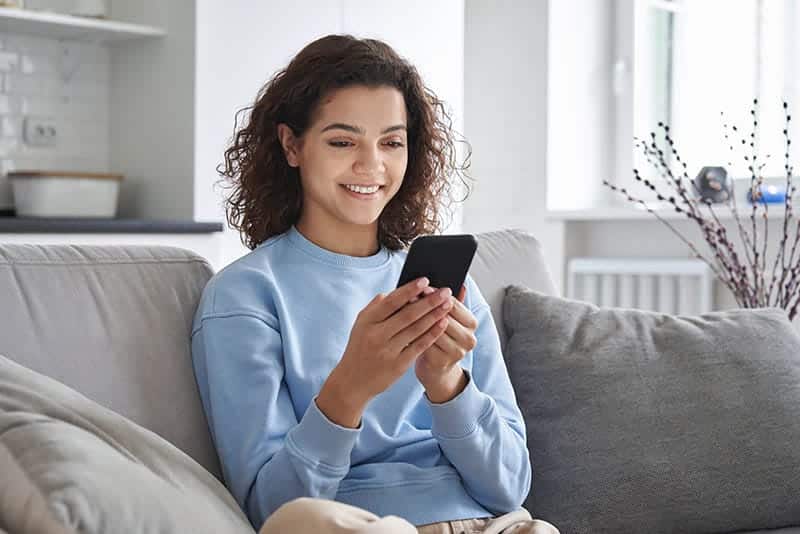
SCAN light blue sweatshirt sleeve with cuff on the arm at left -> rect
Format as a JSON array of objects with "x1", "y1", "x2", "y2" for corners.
[{"x1": 192, "y1": 314, "x2": 360, "y2": 529}]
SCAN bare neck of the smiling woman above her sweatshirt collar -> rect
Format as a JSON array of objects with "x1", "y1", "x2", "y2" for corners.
[{"x1": 295, "y1": 217, "x2": 380, "y2": 258}]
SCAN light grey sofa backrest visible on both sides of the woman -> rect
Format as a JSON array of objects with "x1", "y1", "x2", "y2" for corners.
[{"x1": 0, "y1": 230, "x2": 555, "y2": 478}]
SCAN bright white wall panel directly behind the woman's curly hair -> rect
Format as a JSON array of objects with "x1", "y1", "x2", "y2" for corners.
[{"x1": 194, "y1": 0, "x2": 464, "y2": 263}]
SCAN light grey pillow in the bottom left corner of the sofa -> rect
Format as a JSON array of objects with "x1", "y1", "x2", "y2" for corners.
[{"x1": 0, "y1": 356, "x2": 253, "y2": 534}]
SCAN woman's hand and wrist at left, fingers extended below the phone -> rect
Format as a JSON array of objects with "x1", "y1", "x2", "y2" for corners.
[{"x1": 317, "y1": 278, "x2": 452, "y2": 428}]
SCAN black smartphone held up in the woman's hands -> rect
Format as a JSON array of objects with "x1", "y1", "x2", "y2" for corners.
[{"x1": 397, "y1": 234, "x2": 478, "y2": 296}]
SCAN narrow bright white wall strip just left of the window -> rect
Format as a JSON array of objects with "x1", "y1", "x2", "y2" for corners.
[{"x1": 548, "y1": 0, "x2": 615, "y2": 214}]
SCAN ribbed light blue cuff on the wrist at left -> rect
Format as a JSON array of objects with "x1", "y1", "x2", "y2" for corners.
[{"x1": 287, "y1": 397, "x2": 362, "y2": 471}]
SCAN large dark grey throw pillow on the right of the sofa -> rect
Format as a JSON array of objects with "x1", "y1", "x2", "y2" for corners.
[{"x1": 503, "y1": 286, "x2": 800, "y2": 534}]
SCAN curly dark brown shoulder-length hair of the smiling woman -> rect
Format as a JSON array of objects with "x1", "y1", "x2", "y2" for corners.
[{"x1": 217, "y1": 35, "x2": 472, "y2": 250}]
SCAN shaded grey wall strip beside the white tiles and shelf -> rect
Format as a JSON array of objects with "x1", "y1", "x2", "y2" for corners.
[{"x1": 111, "y1": 0, "x2": 195, "y2": 220}]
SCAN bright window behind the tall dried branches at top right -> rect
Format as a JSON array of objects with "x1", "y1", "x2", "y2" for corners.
[{"x1": 617, "y1": 0, "x2": 800, "y2": 196}]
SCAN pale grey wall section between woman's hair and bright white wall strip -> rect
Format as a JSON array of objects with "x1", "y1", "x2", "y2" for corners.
[{"x1": 463, "y1": 0, "x2": 574, "y2": 294}]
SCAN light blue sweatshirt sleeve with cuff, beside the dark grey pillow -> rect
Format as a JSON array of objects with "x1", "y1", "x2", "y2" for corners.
[{"x1": 429, "y1": 283, "x2": 531, "y2": 515}]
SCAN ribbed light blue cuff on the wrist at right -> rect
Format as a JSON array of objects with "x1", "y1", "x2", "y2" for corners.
[{"x1": 425, "y1": 369, "x2": 492, "y2": 439}]
